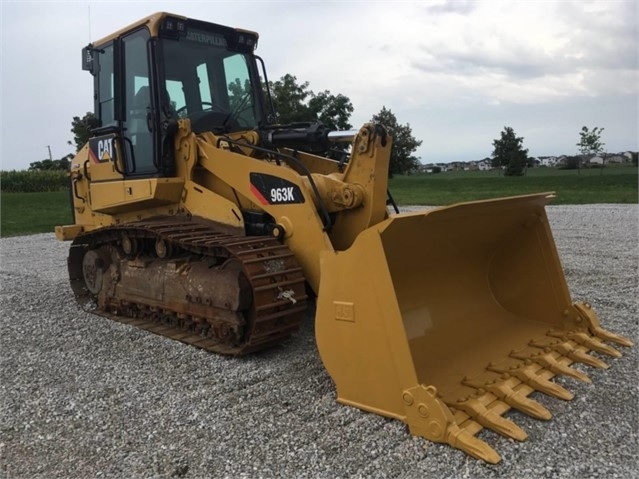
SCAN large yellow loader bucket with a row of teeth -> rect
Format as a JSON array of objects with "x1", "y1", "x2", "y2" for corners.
[{"x1": 316, "y1": 194, "x2": 632, "y2": 463}]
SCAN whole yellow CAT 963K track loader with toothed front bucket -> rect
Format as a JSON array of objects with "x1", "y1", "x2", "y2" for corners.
[{"x1": 56, "y1": 13, "x2": 631, "y2": 463}]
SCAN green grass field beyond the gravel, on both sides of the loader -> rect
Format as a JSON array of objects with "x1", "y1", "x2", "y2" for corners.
[{"x1": 0, "y1": 166, "x2": 638, "y2": 236}]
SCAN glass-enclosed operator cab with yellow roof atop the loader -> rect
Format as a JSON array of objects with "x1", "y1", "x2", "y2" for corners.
[{"x1": 82, "y1": 13, "x2": 266, "y2": 177}]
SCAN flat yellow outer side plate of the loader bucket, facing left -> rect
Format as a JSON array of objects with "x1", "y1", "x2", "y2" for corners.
[{"x1": 315, "y1": 227, "x2": 417, "y2": 418}]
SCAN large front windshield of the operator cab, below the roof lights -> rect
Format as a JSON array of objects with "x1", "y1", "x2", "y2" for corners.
[{"x1": 161, "y1": 29, "x2": 260, "y2": 133}]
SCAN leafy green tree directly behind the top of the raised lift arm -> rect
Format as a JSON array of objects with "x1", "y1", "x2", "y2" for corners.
[{"x1": 371, "y1": 106, "x2": 422, "y2": 178}]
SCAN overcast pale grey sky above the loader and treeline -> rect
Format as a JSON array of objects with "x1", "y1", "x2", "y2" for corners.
[{"x1": 0, "y1": 0, "x2": 639, "y2": 170}]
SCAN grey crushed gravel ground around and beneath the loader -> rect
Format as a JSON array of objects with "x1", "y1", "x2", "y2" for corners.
[{"x1": 0, "y1": 205, "x2": 639, "y2": 479}]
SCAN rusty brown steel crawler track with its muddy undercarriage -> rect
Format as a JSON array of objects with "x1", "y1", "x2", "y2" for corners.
[{"x1": 68, "y1": 217, "x2": 307, "y2": 355}]
